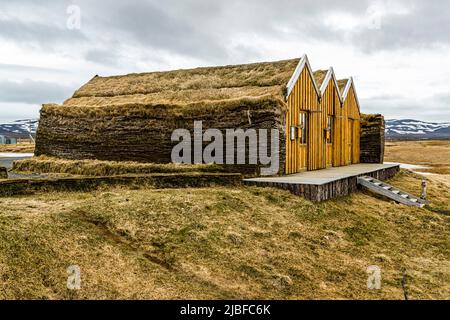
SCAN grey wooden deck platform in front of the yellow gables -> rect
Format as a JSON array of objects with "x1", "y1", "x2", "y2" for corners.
[{"x1": 244, "y1": 163, "x2": 400, "y2": 202}]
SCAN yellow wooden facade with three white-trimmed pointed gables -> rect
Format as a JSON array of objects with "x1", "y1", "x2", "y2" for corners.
[{"x1": 285, "y1": 57, "x2": 360, "y2": 174}]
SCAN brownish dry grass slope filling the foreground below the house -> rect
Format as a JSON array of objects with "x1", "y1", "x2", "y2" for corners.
[{"x1": 0, "y1": 172, "x2": 450, "y2": 299}]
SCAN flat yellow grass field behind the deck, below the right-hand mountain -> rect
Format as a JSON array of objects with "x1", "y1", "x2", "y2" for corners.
[{"x1": 385, "y1": 140, "x2": 450, "y2": 174}]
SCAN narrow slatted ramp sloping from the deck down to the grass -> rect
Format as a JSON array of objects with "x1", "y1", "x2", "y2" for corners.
[{"x1": 358, "y1": 176, "x2": 428, "y2": 208}]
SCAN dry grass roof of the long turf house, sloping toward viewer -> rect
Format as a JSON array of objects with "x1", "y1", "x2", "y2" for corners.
[{"x1": 64, "y1": 59, "x2": 300, "y2": 107}]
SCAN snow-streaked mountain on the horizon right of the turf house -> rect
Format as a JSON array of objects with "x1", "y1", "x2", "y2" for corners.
[{"x1": 386, "y1": 119, "x2": 450, "y2": 139}]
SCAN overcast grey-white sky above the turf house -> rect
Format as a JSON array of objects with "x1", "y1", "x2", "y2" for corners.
[{"x1": 0, "y1": 0, "x2": 450, "y2": 122}]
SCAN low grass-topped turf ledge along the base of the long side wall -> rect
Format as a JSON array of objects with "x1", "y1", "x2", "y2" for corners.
[{"x1": 13, "y1": 156, "x2": 223, "y2": 176}]
